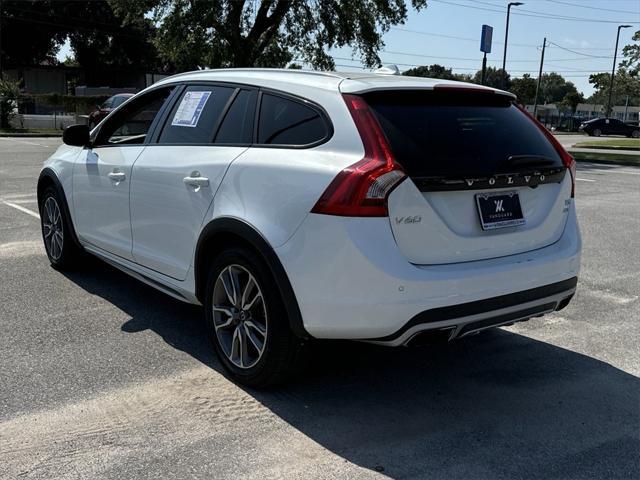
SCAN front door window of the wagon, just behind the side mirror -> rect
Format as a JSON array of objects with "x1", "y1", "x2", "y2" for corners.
[{"x1": 94, "y1": 87, "x2": 173, "y2": 146}]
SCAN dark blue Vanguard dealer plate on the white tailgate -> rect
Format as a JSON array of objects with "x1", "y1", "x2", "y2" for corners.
[{"x1": 476, "y1": 191, "x2": 525, "y2": 230}]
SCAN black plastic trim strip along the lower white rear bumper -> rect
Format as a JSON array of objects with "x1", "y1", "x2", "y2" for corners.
[{"x1": 369, "y1": 277, "x2": 578, "y2": 342}]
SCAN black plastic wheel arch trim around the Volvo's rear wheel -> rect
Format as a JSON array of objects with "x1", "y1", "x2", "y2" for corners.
[{"x1": 194, "y1": 217, "x2": 312, "y2": 339}]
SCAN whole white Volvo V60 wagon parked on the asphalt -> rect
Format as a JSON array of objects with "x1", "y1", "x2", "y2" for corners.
[{"x1": 38, "y1": 69, "x2": 581, "y2": 386}]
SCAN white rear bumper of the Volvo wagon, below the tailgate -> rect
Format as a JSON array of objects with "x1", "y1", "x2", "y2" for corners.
[{"x1": 276, "y1": 204, "x2": 581, "y2": 345}]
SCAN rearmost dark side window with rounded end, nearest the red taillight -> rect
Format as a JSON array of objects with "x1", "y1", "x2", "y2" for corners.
[{"x1": 258, "y1": 93, "x2": 329, "y2": 145}]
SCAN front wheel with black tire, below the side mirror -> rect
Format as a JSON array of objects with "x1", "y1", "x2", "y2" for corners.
[{"x1": 39, "y1": 187, "x2": 85, "y2": 270}]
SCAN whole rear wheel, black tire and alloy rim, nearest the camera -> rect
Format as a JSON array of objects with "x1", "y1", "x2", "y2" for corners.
[{"x1": 205, "y1": 248, "x2": 305, "y2": 387}]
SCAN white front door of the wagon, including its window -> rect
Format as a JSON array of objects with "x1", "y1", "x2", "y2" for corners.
[{"x1": 73, "y1": 88, "x2": 171, "y2": 259}]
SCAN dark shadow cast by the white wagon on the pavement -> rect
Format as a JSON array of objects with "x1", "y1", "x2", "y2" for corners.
[{"x1": 62, "y1": 267, "x2": 640, "y2": 479}]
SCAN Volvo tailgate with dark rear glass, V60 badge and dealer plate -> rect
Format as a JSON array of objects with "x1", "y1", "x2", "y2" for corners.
[{"x1": 365, "y1": 89, "x2": 571, "y2": 264}]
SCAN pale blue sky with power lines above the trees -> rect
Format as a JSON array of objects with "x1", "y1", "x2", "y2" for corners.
[{"x1": 58, "y1": 0, "x2": 640, "y2": 97}]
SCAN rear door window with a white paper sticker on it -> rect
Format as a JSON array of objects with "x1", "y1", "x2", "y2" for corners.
[{"x1": 158, "y1": 85, "x2": 235, "y2": 144}]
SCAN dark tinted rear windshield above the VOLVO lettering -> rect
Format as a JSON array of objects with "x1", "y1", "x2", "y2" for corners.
[{"x1": 364, "y1": 91, "x2": 562, "y2": 177}]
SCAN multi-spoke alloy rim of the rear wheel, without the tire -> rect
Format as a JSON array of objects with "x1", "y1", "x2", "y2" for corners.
[{"x1": 212, "y1": 264, "x2": 268, "y2": 369}]
